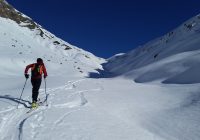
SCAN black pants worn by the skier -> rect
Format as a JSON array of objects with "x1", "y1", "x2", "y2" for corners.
[{"x1": 31, "y1": 78, "x2": 42, "y2": 102}]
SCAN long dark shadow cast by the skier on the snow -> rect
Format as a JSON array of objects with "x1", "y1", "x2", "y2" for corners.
[{"x1": 0, "y1": 95, "x2": 31, "y2": 108}]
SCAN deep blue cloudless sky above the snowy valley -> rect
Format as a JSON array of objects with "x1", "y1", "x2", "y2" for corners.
[{"x1": 7, "y1": 0, "x2": 200, "y2": 58}]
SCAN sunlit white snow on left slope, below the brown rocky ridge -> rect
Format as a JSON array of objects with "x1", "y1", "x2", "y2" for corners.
[{"x1": 0, "y1": 18, "x2": 103, "y2": 75}]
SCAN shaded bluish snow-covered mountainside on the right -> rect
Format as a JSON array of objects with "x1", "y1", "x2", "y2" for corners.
[{"x1": 105, "y1": 15, "x2": 200, "y2": 83}]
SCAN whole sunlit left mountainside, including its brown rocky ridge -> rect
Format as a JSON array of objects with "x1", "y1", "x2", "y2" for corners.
[{"x1": 0, "y1": 0, "x2": 104, "y2": 76}]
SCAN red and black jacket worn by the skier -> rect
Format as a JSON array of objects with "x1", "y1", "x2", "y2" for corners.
[{"x1": 24, "y1": 63, "x2": 47, "y2": 79}]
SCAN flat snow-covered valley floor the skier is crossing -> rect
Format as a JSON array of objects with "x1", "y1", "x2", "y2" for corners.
[{"x1": 0, "y1": 75, "x2": 200, "y2": 140}]
